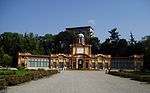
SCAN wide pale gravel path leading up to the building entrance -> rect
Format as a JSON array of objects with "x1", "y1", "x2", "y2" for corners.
[{"x1": 7, "y1": 71, "x2": 150, "y2": 93}]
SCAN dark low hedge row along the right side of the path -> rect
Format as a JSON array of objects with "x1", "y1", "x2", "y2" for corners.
[{"x1": 109, "y1": 71, "x2": 150, "y2": 82}]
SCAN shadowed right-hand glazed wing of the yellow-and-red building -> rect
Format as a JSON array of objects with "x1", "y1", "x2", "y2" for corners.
[{"x1": 111, "y1": 55, "x2": 143, "y2": 71}]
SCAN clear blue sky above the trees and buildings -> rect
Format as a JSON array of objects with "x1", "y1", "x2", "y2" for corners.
[{"x1": 0, "y1": 0, "x2": 150, "y2": 42}]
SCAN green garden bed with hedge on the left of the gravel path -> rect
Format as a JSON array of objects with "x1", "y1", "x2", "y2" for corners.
[{"x1": 0, "y1": 69, "x2": 58, "y2": 86}]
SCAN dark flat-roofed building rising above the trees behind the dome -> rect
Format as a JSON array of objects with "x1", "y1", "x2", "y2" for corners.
[{"x1": 66, "y1": 26, "x2": 94, "y2": 38}]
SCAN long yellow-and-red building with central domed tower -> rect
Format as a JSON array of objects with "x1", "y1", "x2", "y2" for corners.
[{"x1": 18, "y1": 28, "x2": 143, "y2": 70}]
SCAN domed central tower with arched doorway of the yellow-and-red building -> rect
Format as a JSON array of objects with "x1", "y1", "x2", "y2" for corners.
[{"x1": 70, "y1": 33, "x2": 91, "y2": 69}]
